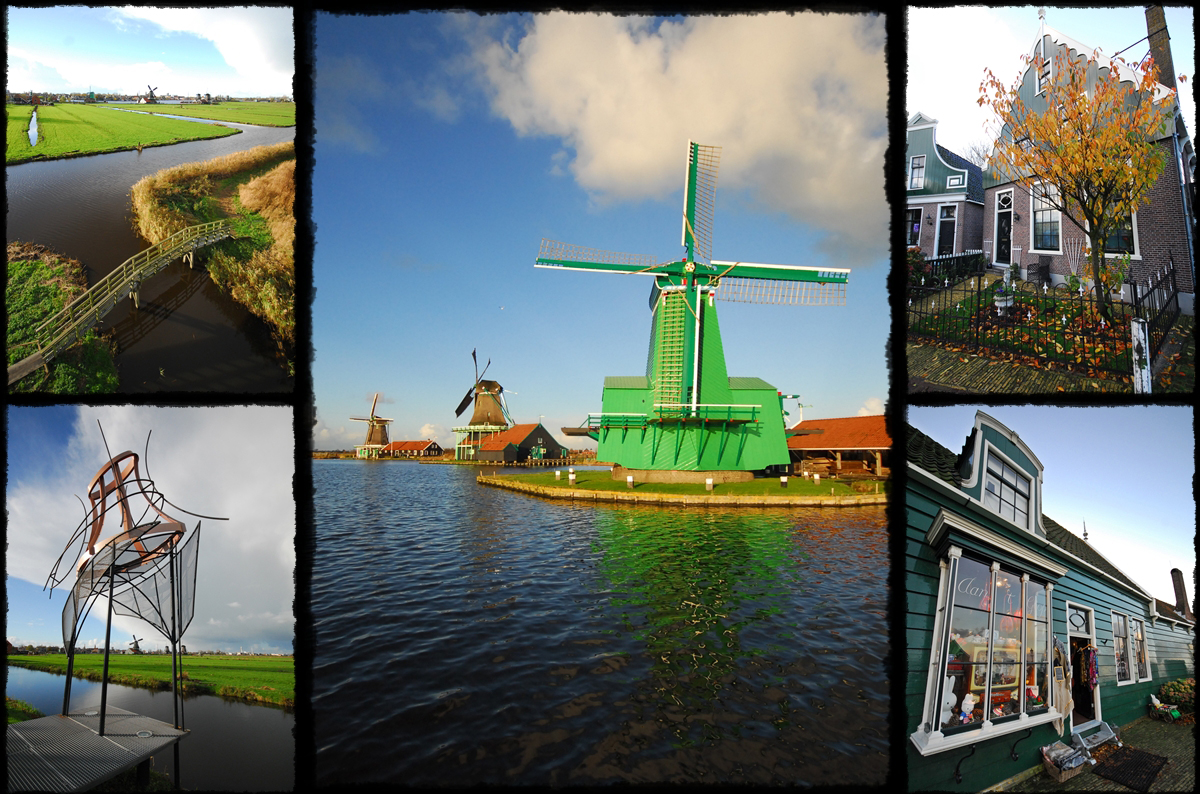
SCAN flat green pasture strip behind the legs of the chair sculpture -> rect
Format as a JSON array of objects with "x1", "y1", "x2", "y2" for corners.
[{"x1": 7, "y1": 654, "x2": 295, "y2": 709}]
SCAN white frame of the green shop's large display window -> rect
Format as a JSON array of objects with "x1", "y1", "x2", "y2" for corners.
[{"x1": 908, "y1": 542, "x2": 1064, "y2": 756}]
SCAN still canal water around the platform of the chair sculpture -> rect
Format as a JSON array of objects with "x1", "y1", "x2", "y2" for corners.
[{"x1": 5, "y1": 667, "x2": 295, "y2": 792}]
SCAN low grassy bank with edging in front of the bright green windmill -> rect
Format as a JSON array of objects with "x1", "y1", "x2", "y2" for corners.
[{"x1": 500, "y1": 469, "x2": 890, "y2": 497}]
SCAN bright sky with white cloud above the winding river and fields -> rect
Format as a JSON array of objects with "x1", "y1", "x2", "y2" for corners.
[{"x1": 6, "y1": 6, "x2": 295, "y2": 97}]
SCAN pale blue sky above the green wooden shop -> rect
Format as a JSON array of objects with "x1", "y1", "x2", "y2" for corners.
[{"x1": 908, "y1": 405, "x2": 1196, "y2": 611}]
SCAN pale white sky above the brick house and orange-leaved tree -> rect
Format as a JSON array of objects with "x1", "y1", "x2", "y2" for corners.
[{"x1": 905, "y1": 5, "x2": 1196, "y2": 154}]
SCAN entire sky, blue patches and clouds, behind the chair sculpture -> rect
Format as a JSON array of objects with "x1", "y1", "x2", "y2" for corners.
[{"x1": 5, "y1": 405, "x2": 295, "y2": 652}]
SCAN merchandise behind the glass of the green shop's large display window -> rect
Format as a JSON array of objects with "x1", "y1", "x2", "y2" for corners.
[{"x1": 935, "y1": 557, "x2": 1049, "y2": 734}]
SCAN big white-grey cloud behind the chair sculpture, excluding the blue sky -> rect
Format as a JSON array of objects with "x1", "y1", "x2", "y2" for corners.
[{"x1": 5, "y1": 405, "x2": 295, "y2": 651}]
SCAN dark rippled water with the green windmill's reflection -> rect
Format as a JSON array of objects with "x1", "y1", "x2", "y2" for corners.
[{"x1": 312, "y1": 461, "x2": 889, "y2": 786}]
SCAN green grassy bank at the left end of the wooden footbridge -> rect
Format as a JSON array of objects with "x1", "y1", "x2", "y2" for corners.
[{"x1": 5, "y1": 242, "x2": 118, "y2": 395}]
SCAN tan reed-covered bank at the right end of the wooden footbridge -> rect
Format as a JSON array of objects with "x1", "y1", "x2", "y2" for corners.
[{"x1": 131, "y1": 142, "x2": 295, "y2": 368}]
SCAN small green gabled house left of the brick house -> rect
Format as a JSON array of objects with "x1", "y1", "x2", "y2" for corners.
[{"x1": 905, "y1": 113, "x2": 983, "y2": 258}]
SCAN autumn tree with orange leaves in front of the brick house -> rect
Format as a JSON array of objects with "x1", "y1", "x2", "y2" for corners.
[{"x1": 979, "y1": 50, "x2": 1175, "y2": 321}]
